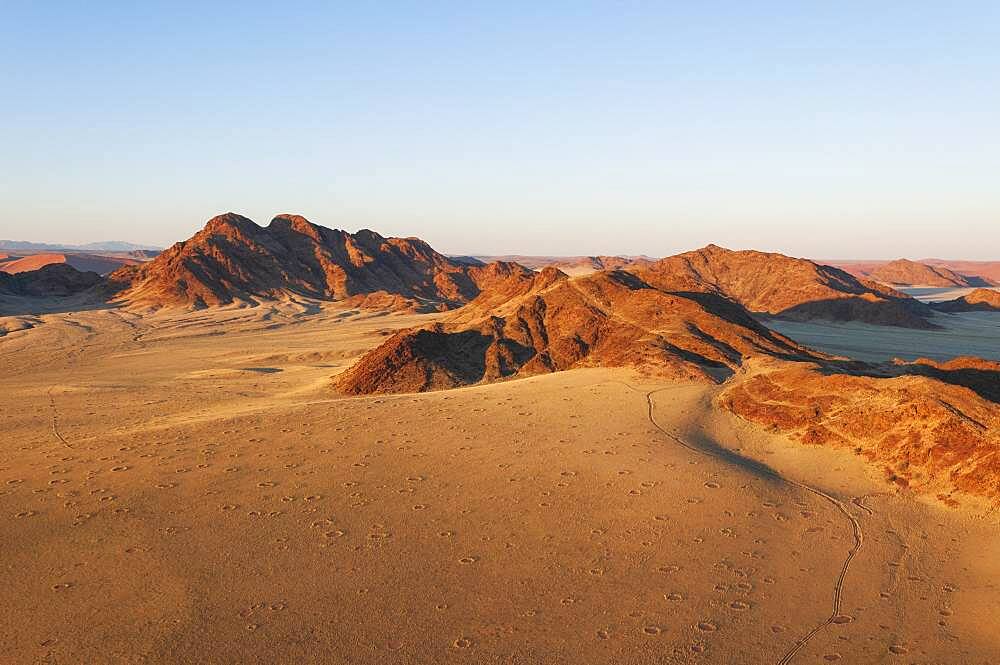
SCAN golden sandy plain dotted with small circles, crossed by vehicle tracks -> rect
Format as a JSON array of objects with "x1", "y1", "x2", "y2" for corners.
[{"x1": 0, "y1": 303, "x2": 1000, "y2": 664}]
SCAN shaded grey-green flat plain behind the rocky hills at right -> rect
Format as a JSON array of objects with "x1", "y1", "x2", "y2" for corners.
[{"x1": 767, "y1": 312, "x2": 1000, "y2": 362}]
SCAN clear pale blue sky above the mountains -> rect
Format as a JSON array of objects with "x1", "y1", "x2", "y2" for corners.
[{"x1": 0, "y1": 0, "x2": 1000, "y2": 259}]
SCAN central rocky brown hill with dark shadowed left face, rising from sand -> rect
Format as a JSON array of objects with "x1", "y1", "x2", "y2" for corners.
[{"x1": 337, "y1": 268, "x2": 819, "y2": 394}]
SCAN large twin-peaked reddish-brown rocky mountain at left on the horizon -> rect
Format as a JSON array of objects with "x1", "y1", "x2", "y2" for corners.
[{"x1": 109, "y1": 213, "x2": 529, "y2": 311}]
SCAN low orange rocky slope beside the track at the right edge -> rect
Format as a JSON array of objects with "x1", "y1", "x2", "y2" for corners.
[{"x1": 718, "y1": 359, "x2": 1000, "y2": 503}]
